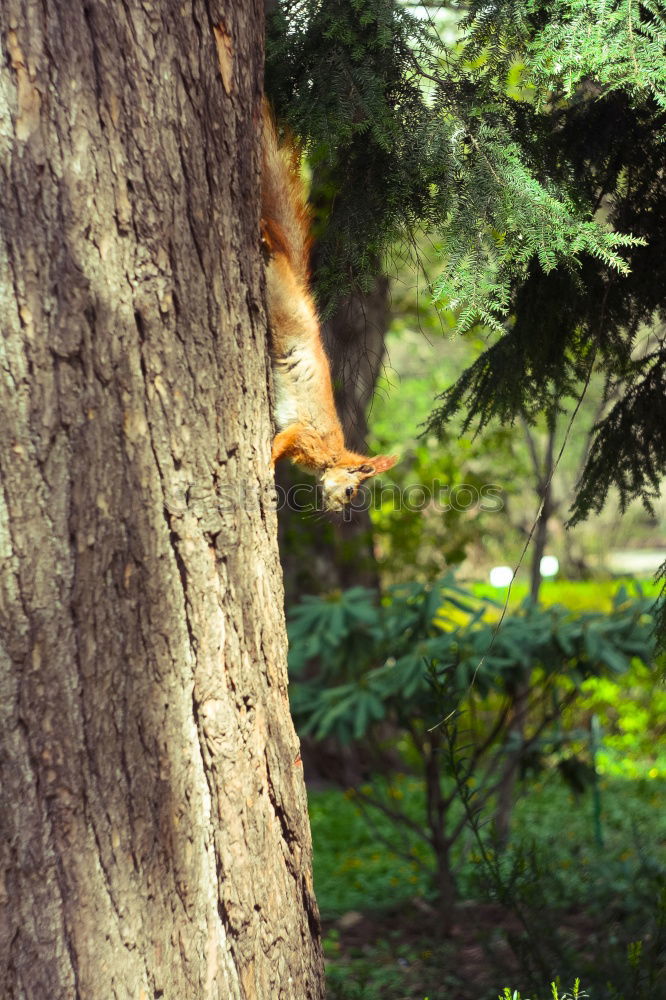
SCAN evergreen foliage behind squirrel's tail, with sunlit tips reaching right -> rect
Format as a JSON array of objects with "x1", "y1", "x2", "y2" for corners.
[{"x1": 266, "y1": 0, "x2": 636, "y2": 331}]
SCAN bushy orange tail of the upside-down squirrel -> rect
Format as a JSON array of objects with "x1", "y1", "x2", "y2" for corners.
[{"x1": 261, "y1": 101, "x2": 310, "y2": 286}]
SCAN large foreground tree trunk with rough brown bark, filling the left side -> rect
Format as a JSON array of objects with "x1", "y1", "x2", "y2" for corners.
[{"x1": 0, "y1": 0, "x2": 323, "y2": 1000}]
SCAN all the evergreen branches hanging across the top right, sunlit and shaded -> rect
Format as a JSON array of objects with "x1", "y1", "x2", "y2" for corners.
[{"x1": 267, "y1": 0, "x2": 666, "y2": 632}]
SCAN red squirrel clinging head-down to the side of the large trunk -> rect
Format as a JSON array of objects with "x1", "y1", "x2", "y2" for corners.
[{"x1": 261, "y1": 105, "x2": 397, "y2": 510}]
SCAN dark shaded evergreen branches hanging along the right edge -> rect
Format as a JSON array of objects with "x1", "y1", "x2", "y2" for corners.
[{"x1": 422, "y1": 84, "x2": 666, "y2": 616}]
